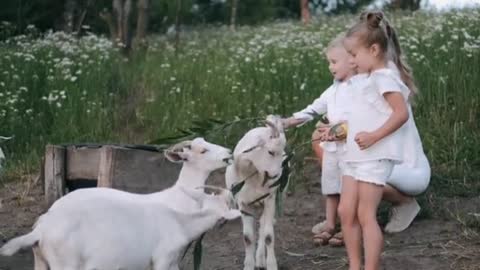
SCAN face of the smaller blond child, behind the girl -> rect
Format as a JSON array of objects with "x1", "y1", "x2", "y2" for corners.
[{"x1": 327, "y1": 47, "x2": 354, "y2": 81}]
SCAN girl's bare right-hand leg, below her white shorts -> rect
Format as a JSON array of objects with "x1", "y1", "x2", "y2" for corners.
[{"x1": 357, "y1": 181, "x2": 383, "y2": 270}]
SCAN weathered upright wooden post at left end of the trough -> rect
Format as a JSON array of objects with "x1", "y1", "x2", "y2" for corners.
[{"x1": 45, "y1": 145, "x2": 65, "y2": 207}]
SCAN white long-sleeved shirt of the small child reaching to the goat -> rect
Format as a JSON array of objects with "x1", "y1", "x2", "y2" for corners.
[{"x1": 293, "y1": 74, "x2": 367, "y2": 152}]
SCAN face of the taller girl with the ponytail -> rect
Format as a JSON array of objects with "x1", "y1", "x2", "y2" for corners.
[{"x1": 344, "y1": 36, "x2": 379, "y2": 73}]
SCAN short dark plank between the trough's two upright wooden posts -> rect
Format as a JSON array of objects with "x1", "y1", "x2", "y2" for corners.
[{"x1": 65, "y1": 146, "x2": 101, "y2": 180}]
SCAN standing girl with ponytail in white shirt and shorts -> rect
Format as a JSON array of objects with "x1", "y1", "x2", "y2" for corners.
[{"x1": 338, "y1": 12, "x2": 415, "y2": 270}]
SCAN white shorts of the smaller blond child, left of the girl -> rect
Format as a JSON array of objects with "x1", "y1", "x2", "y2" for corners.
[{"x1": 321, "y1": 151, "x2": 342, "y2": 195}]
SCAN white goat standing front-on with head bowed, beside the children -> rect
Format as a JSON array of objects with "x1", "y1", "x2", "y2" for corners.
[{"x1": 225, "y1": 116, "x2": 286, "y2": 270}]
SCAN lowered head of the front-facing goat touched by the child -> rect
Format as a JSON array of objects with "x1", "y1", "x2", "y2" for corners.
[{"x1": 243, "y1": 115, "x2": 287, "y2": 180}]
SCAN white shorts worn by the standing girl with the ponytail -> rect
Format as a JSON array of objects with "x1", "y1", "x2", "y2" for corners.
[{"x1": 340, "y1": 159, "x2": 394, "y2": 186}]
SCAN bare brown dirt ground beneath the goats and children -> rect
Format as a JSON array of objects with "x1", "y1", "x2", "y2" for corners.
[{"x1": 0, "y1": 162, "x2": 480, "y2": 270}]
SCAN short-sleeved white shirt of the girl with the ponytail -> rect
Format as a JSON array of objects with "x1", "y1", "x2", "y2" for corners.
[{"x1": 344, "y1": 68, "x2": 411, "y2": 164}]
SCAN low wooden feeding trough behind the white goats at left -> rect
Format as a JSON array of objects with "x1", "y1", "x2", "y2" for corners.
[{"x1": 43, "y1": 144, "x2": 181, "y2": 206}]
